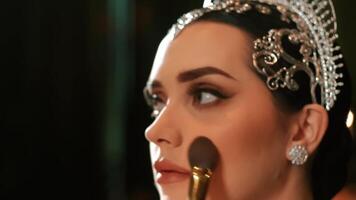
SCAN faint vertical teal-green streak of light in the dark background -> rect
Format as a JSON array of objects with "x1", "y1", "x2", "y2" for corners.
[{"x1": 104, "y1": 0, "x2": 134, "y2": 200}]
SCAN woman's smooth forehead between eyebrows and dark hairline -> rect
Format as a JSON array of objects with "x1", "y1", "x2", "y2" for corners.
[{"x1": 150, "y1": 21, "x2": 252, "y2": 80}]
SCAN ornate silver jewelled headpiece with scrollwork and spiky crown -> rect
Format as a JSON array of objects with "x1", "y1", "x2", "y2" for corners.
[{"x1": 170, "y1": 0, "x2": 343, "y2": 110}]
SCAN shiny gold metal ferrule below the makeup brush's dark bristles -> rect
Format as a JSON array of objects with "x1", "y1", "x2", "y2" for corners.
[{"x1": 189, "y1": 166, "x2": 213, "y2": 200}]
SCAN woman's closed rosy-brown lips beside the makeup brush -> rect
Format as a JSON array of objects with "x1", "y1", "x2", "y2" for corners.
[{"x1": 154, "y1": 159, "x2": 191, "y2": 185}]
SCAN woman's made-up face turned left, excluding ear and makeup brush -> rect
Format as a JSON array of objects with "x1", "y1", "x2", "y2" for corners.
[{"x1": 146, "y1": 22, "x2": 288, "y2": 200}]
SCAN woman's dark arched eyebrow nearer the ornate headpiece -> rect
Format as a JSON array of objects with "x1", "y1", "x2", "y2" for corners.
[{"x1": 177, "y1": 66, "x2": 236, "y2": 82}]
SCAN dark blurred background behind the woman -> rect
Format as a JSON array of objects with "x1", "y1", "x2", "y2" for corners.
[{"x1": 0, "y1": 0, "x2": 356, "y2": 200}]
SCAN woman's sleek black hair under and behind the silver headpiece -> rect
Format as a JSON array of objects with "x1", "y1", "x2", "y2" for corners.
[{"x1": 198, "y1": 3, "x2": 352, "y2": 200}]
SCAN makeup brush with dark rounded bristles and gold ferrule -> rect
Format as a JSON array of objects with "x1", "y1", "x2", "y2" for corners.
[{"x1": 188, "y1": 137, "x2": 219, "y2": 200}]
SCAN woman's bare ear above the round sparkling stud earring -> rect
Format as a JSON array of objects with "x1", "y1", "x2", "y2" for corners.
[{"x1": 286, "y1": 104, "x2": 329, "y2": 154}]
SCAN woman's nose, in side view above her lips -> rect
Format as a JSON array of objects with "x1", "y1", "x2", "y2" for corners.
[{"x1": 145, "y1": 105, "x2": 182, "y2": 147}]
